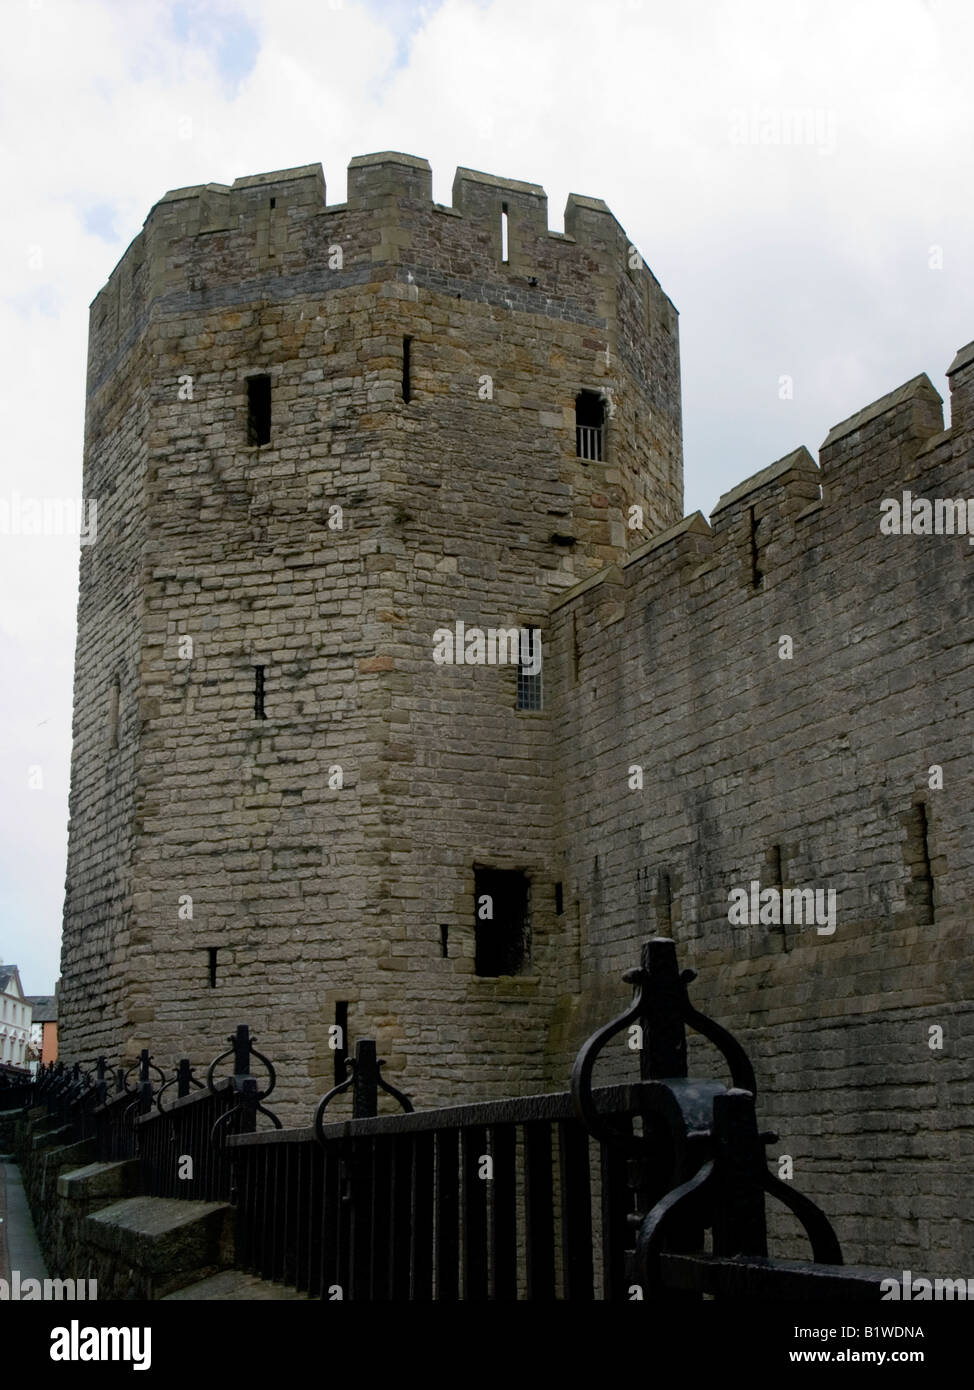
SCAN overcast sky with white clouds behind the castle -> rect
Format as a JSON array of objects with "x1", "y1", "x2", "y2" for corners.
[{"x1": 0, "y1": 0, "x2": 974, "y2": 994}]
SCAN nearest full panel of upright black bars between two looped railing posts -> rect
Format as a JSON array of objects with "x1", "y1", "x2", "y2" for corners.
[{"x1": 229, "y1": 1067, "x2": 642, "y2": 1301}]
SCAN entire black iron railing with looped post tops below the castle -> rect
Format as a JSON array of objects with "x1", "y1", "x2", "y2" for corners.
[{"x1": 0, "y1": 938, "x2": 888, "y2": 1301}]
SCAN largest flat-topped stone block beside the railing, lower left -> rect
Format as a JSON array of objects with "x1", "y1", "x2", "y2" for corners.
[{"x1": 85, "y1": 1197, "x2": 233, "y2": 1300}]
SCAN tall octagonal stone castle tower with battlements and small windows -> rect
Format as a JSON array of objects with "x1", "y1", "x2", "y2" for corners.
[{"x1": 61, "y1": 153, "x2": 682, "y2": 1113}]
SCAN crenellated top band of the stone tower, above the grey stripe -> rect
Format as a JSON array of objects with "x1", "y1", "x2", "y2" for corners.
[{"x1": 89, "y1": 153, "x2": 682, "y2": 478}]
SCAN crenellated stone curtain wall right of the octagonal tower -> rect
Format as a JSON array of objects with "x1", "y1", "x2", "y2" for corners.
[{"x1": 549, "y1": 348, "x2": 974, "y2": 1273}]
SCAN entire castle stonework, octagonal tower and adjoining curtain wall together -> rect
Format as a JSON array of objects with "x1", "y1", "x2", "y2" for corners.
[{"x1": 61, "y1": 153, "x2": 974, "y2": 1270}]
